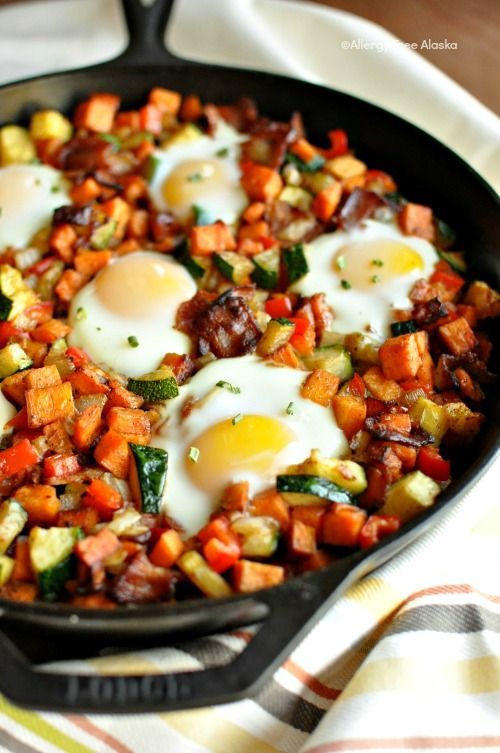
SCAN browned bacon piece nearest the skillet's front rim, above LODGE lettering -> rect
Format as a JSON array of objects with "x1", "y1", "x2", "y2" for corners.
[{"x1": 112, "y1": 552, "x2": 176, "y2": 604}]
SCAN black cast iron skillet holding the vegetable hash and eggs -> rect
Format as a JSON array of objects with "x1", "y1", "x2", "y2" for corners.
[{"x1": 0, "y1": 0, "x2": 500, "y2": 712}]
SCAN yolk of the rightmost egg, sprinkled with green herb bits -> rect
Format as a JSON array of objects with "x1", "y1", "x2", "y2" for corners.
[{"x1": 333, "y1": 240, "x2": 424, "y2": 289}]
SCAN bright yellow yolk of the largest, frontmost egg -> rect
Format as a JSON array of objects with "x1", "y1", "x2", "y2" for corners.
[{"x1": 186, "y1": 415, "x2": 296, "y2": 494}]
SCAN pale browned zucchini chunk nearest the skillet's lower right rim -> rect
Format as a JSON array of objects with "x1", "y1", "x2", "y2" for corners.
[{"x1": 378, "y1": 471, "x2": 441, "y2": 523}]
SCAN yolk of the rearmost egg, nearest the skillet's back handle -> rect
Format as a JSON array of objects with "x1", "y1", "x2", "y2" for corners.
[{"x1": 163, "y1": 159, "x2": 227, "y2": 211}]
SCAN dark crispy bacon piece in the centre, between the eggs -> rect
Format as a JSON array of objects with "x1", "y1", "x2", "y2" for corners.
[{"x1": 195, "y1": 290, "x2": 262, "y2": 358}]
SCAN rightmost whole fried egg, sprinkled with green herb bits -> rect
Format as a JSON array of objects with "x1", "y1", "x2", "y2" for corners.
[{"x1": 291, "y1": 220, "x2": 439, "y2": 340}]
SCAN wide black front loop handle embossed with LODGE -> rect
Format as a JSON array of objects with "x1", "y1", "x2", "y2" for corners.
[{"x1": 0, "y1": 568, "x2": 351, "y2": 713}]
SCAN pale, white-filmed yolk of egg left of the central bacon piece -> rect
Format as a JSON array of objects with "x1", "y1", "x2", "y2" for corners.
[{"x1": 95, "y1": 253, "x2": 196, "y2": 319}]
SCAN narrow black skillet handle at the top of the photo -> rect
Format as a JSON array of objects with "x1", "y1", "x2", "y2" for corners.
[{"x1": 113, "y1": 0, "x2": 194, "y2": 66}]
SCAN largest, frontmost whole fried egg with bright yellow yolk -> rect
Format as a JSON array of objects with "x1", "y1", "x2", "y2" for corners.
[{"x1": 151, "y1": 355, "x2": 348, "y2": 535}]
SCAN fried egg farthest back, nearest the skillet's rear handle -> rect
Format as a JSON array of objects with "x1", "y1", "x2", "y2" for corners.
[{"x1": 149, "y1": 121, "x2": 248, "y2": 224}]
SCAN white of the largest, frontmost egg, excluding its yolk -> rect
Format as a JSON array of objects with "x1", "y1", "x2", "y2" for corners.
[{"x1": 151, "y1": 355, "x2": 348, "y2": 535}]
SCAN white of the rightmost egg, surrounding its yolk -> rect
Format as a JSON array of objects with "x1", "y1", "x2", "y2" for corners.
[{"x1": 291, "y1": 220, "x2": 439, "y2": 341}]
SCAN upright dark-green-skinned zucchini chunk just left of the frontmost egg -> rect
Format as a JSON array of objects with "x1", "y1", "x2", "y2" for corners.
[{"x1": 129, "y1": 442, "x2": 168, "y2": 515}]
